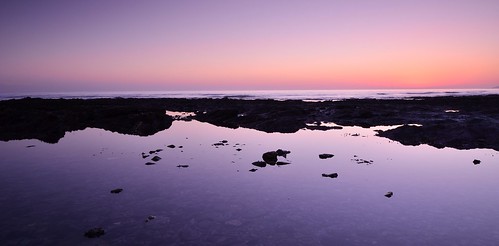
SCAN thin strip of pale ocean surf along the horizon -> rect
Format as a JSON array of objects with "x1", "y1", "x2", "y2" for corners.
[{"x1": 0, "y1": 88, "x2": 499, "y2": 101}]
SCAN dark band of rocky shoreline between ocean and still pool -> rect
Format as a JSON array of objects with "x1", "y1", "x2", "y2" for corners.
[{"x1": 0, "y1": 95, "x2": 499, "y2": 151}]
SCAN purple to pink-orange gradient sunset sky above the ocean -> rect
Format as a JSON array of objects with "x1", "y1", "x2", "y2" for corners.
[{"x1": 0, "y1": 0, "x2": 499, "y2": 92}]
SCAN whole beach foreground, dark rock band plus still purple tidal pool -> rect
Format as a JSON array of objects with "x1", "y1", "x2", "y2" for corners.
[{"x1": 0, "y1": 95, "x2": 499, "y2": 245}]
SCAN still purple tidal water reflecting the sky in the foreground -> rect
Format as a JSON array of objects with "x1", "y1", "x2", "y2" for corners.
[{"x1": 0, "y1": 121, "x2": 499, "y2": 245}]
